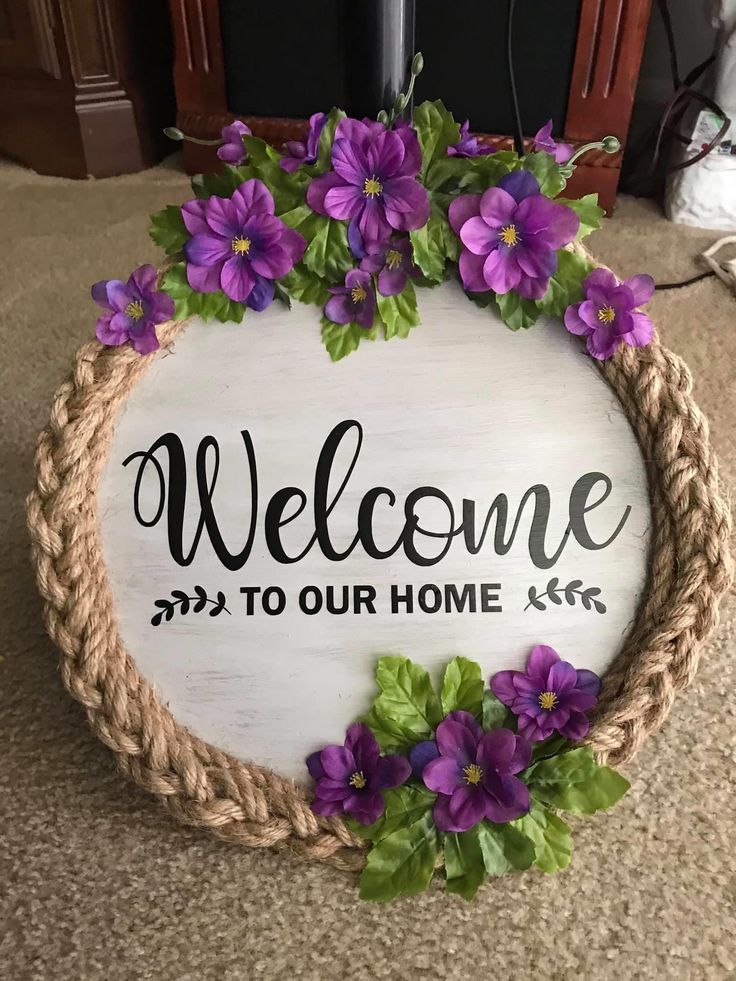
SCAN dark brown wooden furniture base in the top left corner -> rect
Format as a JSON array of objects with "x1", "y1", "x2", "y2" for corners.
[{"x1": 0, "y1": 0, "x2": 174, "y2": 177}]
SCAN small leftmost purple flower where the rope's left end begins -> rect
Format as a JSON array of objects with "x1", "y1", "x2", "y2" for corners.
[{"x1": 91, "y1": 265, "x2": 174, "y2": 354}]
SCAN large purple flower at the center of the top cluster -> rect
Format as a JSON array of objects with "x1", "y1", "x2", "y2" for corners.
[{"x1": 307, "y1": 119, "x2": 429, "y2": 242}]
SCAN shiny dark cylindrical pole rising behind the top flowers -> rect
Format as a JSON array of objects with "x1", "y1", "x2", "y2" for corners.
[{"x1": 345, "y1": 0, "x2": 415, "y2": 118}]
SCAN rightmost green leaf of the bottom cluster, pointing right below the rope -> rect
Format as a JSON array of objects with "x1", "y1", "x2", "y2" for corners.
[{"x1": 527, "y1": 746, "x2": 630, "y2": 814}]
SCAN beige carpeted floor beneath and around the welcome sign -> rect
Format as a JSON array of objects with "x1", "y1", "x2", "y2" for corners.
[{"x1": 0, "y1": 160, "x2": 736, "y2": 981}]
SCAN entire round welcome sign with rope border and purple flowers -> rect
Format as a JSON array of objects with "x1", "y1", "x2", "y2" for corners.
[{"x1": 28, "y1": 80, "x2": 731, "y2": 901}]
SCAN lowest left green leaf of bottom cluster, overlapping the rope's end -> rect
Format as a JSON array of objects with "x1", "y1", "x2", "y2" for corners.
[{"x1": 360, "y1": 813, "x2": 439, "y2": 903}]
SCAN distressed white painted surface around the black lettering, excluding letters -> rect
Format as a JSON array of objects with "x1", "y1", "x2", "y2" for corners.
[{"x1": 100, "y1": 285, "x2": 650, "y2": 778}]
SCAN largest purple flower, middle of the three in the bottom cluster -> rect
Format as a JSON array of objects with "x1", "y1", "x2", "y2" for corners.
[{"x1": 422, "y1": 712, "x2": 532, "y2": 831}]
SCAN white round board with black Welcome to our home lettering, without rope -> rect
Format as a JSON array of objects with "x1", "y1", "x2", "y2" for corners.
[{"x1": 99, "y1": 285, "x2": 651, "y2": 781}]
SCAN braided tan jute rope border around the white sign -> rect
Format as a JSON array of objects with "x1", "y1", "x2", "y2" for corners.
[{"x1": 28, "y1": 262, "x2": 732, "y2": 870}]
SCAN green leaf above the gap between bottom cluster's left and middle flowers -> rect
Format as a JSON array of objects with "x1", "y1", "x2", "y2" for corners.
[{"x1": 362, "y1": 657, "x2": 442, "y2": 752}]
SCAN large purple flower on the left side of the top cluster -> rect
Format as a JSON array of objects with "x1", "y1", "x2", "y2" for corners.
[{"x1": 181, "y1": 178, "x2": 307, "y2": 310}]
